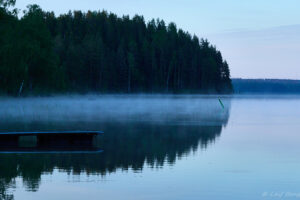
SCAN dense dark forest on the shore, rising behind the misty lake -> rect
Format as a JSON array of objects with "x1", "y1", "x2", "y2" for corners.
[{"x1": 0, "y1": 0, "x2": 232, "y2": 95}]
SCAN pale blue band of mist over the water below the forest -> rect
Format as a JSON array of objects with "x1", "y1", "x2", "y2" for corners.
[{"x1": 0, "y1": 95, "x2": 230, "y2": 131}]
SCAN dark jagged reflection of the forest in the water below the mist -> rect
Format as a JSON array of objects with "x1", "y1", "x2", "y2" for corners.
[{"x1": 0, "y1": 97, "x2": 229, "y2": 199}]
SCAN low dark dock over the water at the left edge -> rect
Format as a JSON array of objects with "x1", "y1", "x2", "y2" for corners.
[{"x1": 0, "y1": 131, "x2": 103, "y2": 154}]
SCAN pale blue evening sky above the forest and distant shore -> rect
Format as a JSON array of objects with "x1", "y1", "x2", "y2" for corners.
[{"x1": 16, "y1": 0, "x2": 300, "y2": 79}]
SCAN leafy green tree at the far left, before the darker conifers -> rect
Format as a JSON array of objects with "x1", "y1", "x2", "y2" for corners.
[{"x1": 0, "y1": 5, "x2": 63, "y2": 95}]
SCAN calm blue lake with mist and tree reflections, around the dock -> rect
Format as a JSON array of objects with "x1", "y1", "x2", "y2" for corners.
[{"x1": 0, "y1": 95, "x2": 300, "y2": 200}]
